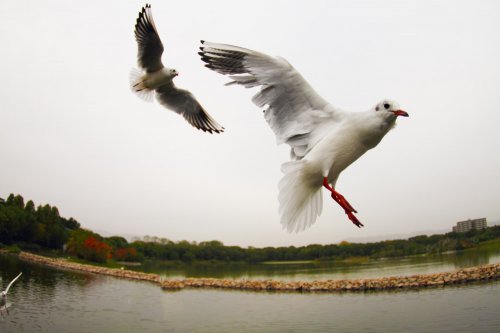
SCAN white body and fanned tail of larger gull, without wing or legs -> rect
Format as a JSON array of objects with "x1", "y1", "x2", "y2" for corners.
[{"x1": 278, "y1": 110, "x2": 394, "y2": 232}]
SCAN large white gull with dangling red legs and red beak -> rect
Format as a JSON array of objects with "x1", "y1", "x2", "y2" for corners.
[{"x1": 199, "y1": 41, "x2": 408, "y2": 232}]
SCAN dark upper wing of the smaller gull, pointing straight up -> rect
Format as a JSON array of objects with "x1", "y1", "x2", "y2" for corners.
[{"x1": 135, "y1": 4, "x2": 163, "y2": 73}]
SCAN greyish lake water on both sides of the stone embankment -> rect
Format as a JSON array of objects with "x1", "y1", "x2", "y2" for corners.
[{"x1": 0, "y1": 245, "x2": 500, "y2": 333}]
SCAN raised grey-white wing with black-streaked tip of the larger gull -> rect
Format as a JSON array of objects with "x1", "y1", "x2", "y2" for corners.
[{"x1": 199, "y1": 41, "x2": 343, "y2": 159}]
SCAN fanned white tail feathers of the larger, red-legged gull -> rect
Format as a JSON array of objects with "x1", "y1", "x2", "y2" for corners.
[{"x1": 278, "y1": 160, "x2": 323, "y2": 232}]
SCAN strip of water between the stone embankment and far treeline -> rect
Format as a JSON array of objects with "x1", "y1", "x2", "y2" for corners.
[{"x1": 131, "y1": 245, "x2": 500, "y2": 280}]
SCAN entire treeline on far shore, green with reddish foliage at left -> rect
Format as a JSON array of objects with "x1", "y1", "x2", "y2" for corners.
[{"x1": 0, "y1": 194, "x2": 500, "y2": 263}]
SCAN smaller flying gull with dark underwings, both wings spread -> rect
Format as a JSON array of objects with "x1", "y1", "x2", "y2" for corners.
[{"x1": 130, "y1": 4, "x2": 224, "y2": 134}]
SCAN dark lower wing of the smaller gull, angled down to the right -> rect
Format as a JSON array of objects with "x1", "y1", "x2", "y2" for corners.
[{"x1": 156, "y1": 83, "x2": 224, "y2": 133}]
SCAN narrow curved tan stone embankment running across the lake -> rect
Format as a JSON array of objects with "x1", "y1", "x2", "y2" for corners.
[{"x1": 17, "y1": 251, "x2": 500, "y2": 292}]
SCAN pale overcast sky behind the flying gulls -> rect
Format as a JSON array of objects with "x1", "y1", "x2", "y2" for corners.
[{"x1": 0, "y1": 0, "x2": 500, "y2": 247}]
